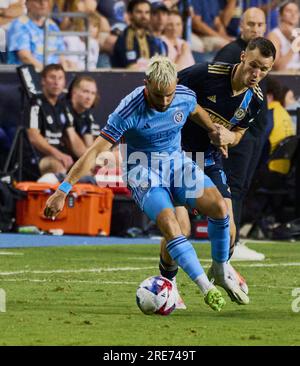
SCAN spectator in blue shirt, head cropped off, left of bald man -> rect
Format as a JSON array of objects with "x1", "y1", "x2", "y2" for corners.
[{"x1": 192, "y1": 0, "x2": 233, "y2": 52}]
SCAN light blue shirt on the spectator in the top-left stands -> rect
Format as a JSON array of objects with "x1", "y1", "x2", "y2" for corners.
[{"x1": 7, "y1": 15, "x2": 65, "y2": 65}]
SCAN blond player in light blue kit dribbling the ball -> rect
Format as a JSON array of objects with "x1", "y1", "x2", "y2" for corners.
[{"x1": 45, "y1": 56, "x2": 243, "y2": 311}]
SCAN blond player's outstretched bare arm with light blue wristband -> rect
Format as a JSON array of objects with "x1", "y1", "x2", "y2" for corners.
[{"x1": 44, "y1": 136, "x2": 112, "y2": 219}]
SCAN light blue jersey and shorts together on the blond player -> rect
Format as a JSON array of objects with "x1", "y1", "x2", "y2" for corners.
[{"x1": 100, "y1": 85, "x2": 214, "y2": 216}]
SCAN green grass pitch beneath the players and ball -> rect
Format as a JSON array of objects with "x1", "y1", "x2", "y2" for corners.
[{"x1": 0, "y1": 243, "x2": 300, "y2": 346}]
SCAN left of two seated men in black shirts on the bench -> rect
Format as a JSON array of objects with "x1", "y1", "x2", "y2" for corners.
[{"x1": 25, "y1": 64, "x2": 86, "y2": 179}]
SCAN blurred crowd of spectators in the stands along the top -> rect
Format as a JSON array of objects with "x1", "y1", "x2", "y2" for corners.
[{"x1": 0, "y1": 0, "x2": 300, "y2": 71}]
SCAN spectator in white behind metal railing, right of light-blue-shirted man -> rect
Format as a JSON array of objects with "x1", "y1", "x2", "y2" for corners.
[{"x1": 64, "y1": 12, "x2": 101, "y2": 71}]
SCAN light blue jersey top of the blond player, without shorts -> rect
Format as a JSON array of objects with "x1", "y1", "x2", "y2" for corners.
[{"x1": 100, "y1": 85, "x2": 197, "y2": 155}]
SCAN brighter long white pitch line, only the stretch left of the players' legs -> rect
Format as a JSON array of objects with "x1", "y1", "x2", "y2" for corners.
[{"x1": 0, "y1": 267, "x2": 156, "y2": 276}]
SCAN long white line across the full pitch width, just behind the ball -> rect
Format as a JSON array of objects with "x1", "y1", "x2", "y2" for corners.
[{"x1": 0, "y1": 262, "x2": 300, "y2": 276}]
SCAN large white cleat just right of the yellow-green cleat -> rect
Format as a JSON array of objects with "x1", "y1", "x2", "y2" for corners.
[{"x1": 207, "y1": 264, "x2": 250, "y2": 305}]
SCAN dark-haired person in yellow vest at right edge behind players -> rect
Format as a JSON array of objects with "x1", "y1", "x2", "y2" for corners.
[{"x1": 260, "y1": 77, "x2": 295, "y2": 174}]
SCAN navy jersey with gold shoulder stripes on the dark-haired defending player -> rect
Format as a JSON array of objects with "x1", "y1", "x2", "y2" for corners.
[{"x1": 178, "y1": 62, "x2": 263, "y2": 166}]
